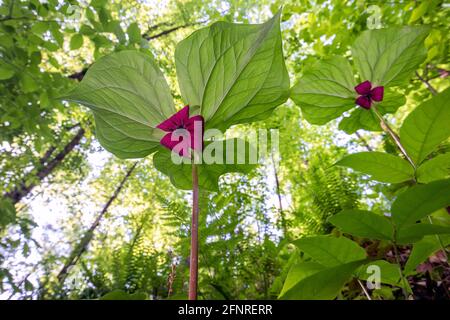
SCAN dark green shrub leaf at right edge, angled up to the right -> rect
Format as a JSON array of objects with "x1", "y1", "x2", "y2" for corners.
[{"x1": 391, "y1": 179, "x2": 450, "y2": 228}]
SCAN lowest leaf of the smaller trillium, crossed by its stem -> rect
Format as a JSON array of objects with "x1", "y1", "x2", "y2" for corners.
[{"x1": 339, "y1": 89, "x2": 406, "y2": 134}]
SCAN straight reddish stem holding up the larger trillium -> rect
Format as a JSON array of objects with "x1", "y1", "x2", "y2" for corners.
[{"x1": 189, "y1": 163, "x2": 199, "y2": 300}]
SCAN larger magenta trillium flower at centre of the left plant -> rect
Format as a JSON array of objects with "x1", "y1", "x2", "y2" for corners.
[{"x1": 157, "y1": 106, "x2": 204, "y2": 157}]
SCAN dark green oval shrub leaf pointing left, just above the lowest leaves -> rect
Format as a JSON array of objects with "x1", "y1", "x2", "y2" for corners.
[{"x1": 328, "y1": 209, "x2": 394, "y2": 240}]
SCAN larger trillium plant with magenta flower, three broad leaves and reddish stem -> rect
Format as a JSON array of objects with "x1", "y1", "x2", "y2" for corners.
[{"x1": 64, "y1": 13, "x2": 289, "y2": 299}]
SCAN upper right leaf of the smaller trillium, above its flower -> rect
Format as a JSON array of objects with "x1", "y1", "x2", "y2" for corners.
[{"x1": 352, "y1": 27, "x2": 429, "y2": 86}]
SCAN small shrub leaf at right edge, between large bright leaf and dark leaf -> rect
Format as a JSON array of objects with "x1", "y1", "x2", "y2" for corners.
[{"x1": 416, "y1": 152, "x2": 450, "y2": 183}]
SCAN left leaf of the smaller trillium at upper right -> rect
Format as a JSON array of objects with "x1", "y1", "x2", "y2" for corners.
[{"x1": 291, "y1": 57, "x2": 356, "y2": 124}]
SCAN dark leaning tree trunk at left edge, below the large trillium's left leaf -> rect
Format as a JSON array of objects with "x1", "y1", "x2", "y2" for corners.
[{"x1": 3, "y1": 128, "x2": 85, "y2": 204}]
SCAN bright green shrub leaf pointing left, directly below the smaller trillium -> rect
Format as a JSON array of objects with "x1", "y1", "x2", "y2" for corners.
[{"x1": 336, "y1": 152, "x2": 414, "y2": 183}]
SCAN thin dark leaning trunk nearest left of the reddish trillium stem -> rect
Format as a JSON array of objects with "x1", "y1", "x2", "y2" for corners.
[{"x1": 57, "y1": 162, "x2": 138, "y2": 285}]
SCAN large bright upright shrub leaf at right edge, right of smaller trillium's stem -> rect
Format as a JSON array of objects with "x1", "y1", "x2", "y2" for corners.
[{"x1": 400, "y1": 88, "x2": 450, "y2": 164}]
